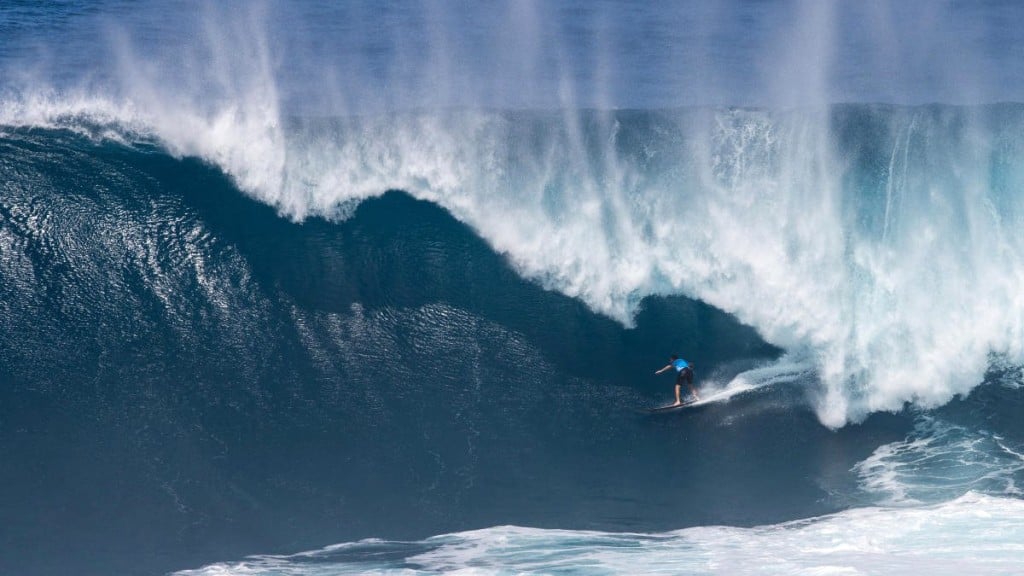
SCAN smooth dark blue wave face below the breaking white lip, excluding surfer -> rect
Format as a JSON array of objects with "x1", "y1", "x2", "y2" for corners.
[{"x1": 0, "y1": 115, "x2": 1024, "y2": 573}]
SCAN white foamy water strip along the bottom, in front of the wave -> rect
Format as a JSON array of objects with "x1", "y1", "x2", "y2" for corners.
[{"x1": 176, "y1": 493, "x2": 1024, "y2": 576}]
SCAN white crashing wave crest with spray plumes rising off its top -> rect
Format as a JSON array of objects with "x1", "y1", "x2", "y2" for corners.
[{"x1": 8, "y1": 0, "x2": 1024, "y2": 426}]
